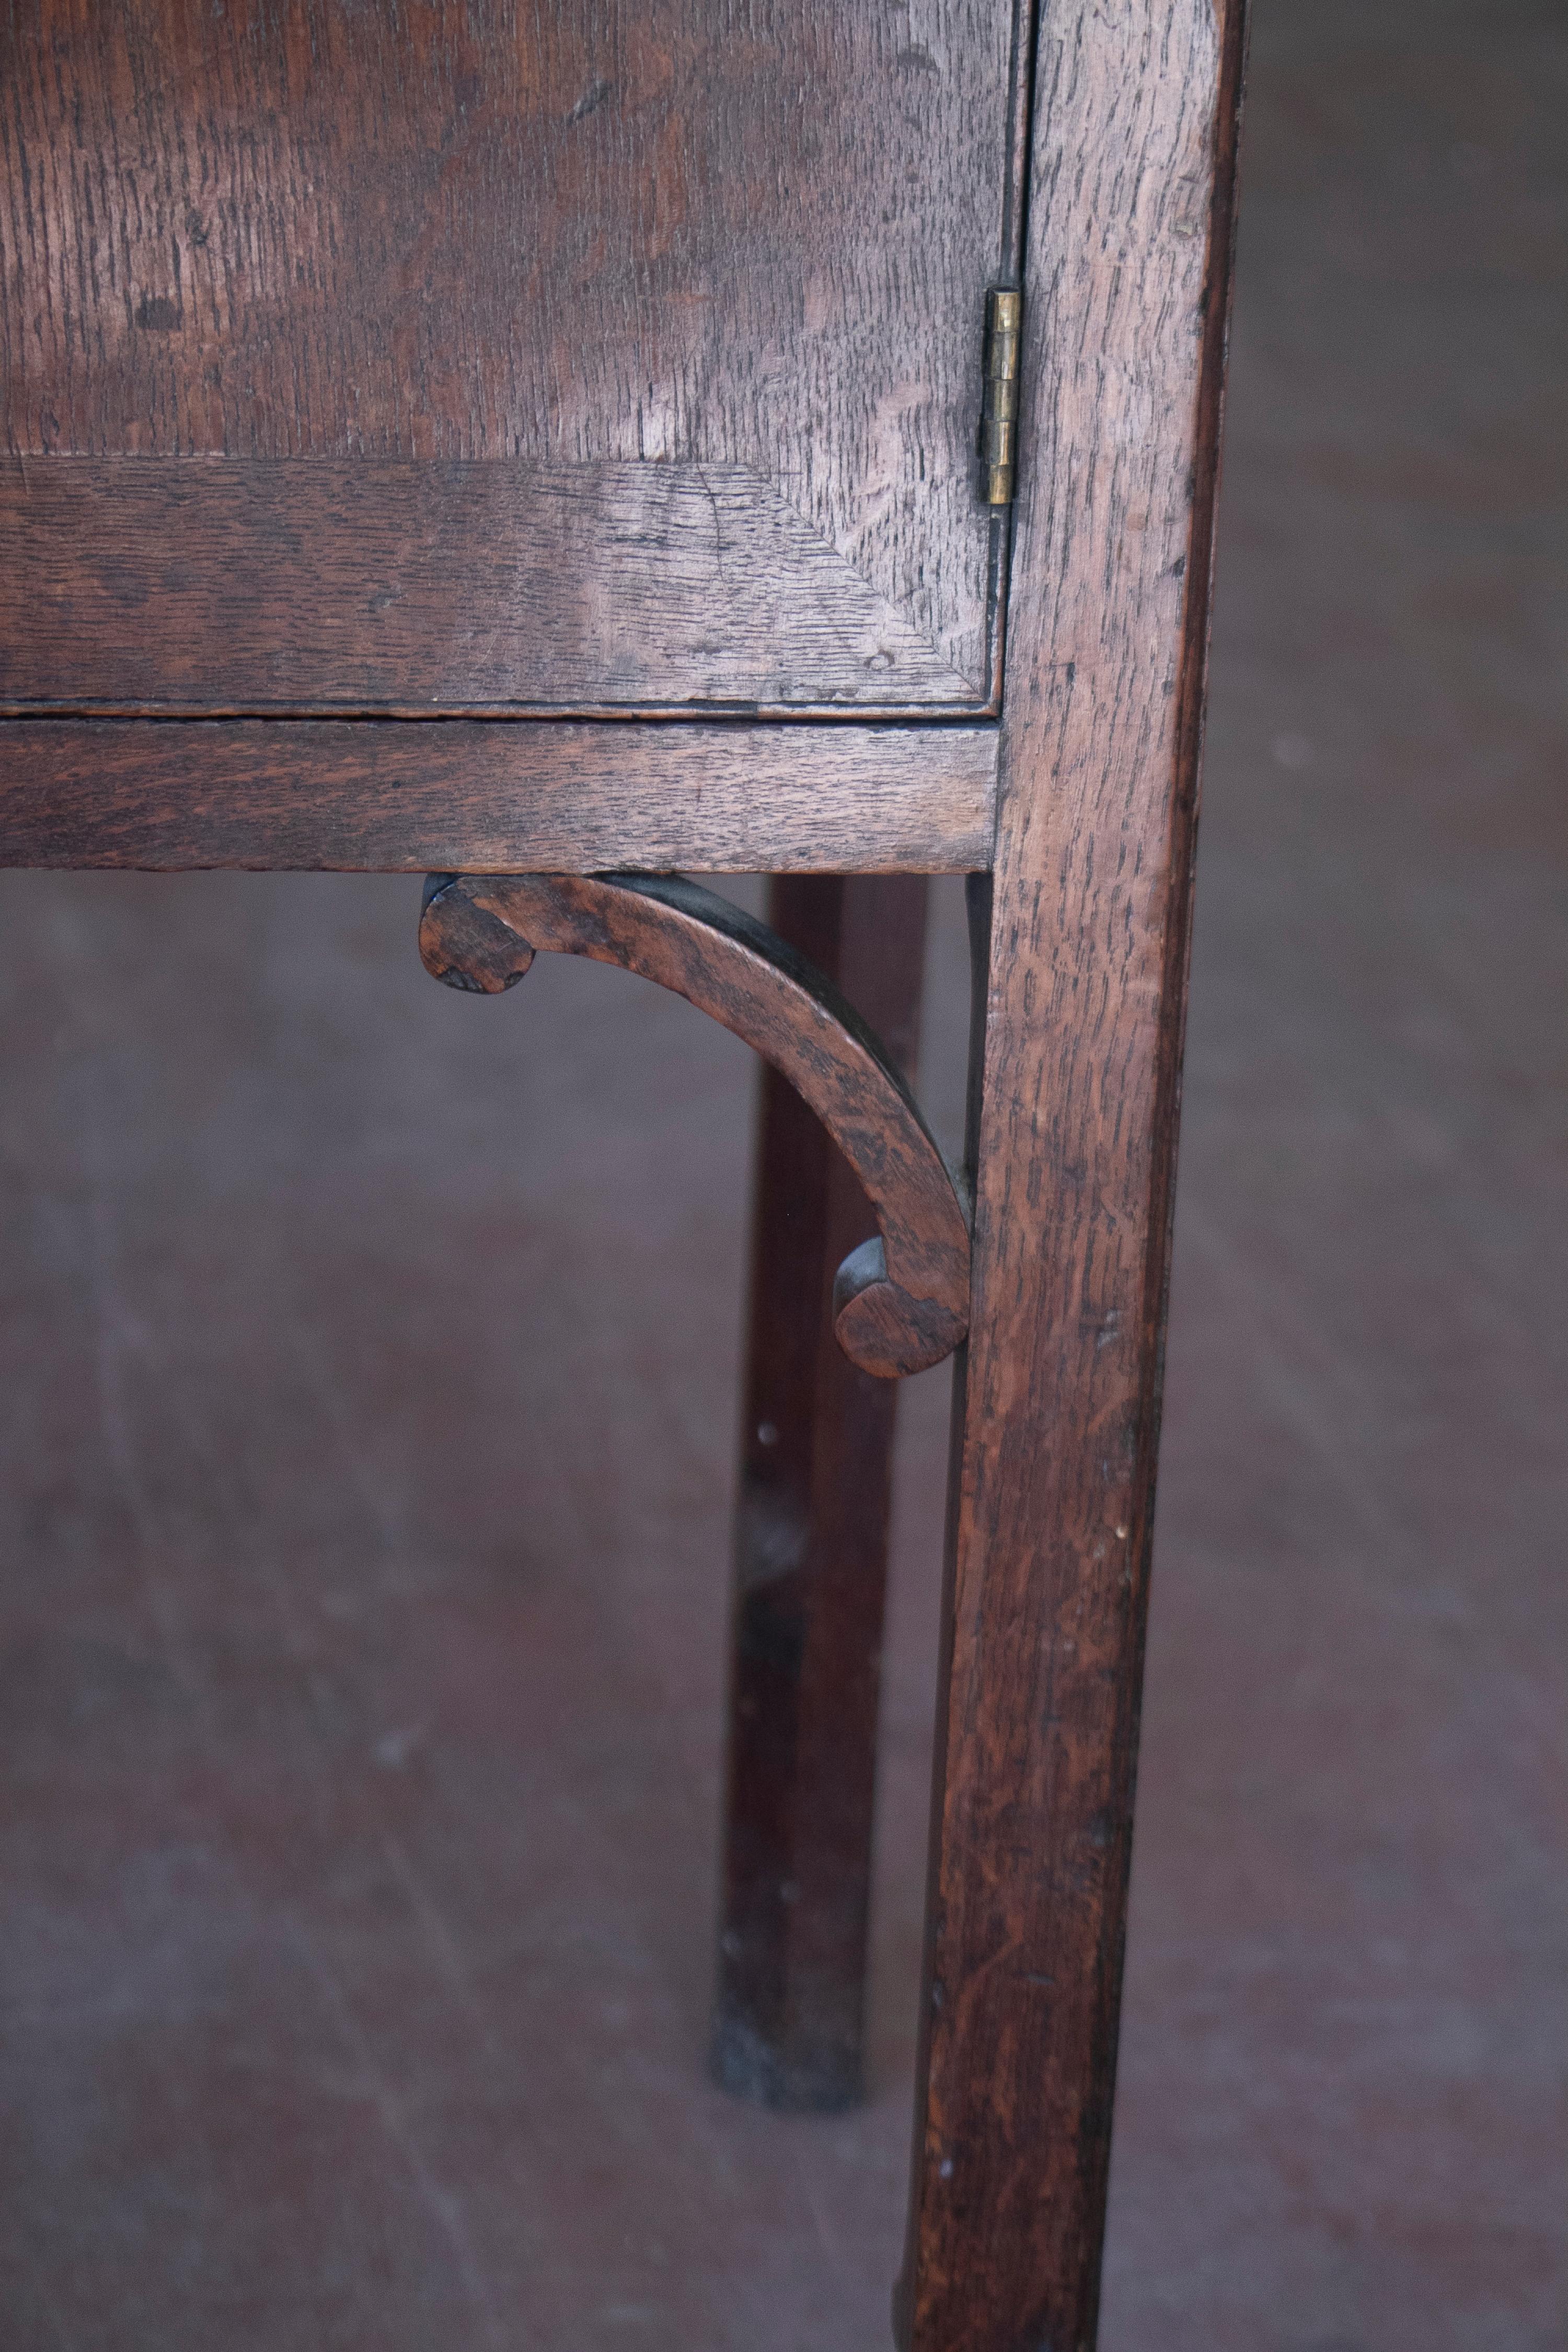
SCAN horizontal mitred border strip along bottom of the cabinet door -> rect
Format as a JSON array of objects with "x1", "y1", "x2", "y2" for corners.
[{"x1": 0, "y1": 459, "x2": 981, "y2": 718}]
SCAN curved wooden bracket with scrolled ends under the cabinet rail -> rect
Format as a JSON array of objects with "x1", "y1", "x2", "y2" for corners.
[{"x1": 419, "y1": 875, "x2": 969, "y2": 1381}]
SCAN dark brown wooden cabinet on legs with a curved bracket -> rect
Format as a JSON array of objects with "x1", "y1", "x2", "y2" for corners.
[{"x1": 0, "y1": 0, "x2": 1243, "y2": 2352}]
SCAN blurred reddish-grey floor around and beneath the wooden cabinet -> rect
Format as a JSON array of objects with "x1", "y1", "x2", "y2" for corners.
[{"x1": 0, "y1": 0, "x2": 1568, "y2": 2352}]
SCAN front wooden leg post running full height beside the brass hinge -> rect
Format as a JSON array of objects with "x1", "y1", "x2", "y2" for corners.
[{"x1": 901, "y1": 0, "x2": 1243, "y2": 2352}]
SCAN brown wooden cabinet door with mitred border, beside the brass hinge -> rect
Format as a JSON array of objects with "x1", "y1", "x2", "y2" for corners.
[{"x1": 0, "y1": 0, "x2": 1018, "y2": 710}]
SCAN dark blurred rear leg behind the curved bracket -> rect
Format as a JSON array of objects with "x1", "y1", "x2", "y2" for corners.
[{"x1": 712, "y1": 875, "x2": 926, "y2": 2110}]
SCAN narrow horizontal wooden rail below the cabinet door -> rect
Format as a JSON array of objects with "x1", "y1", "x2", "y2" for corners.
[{"x1": 0, "y1": 720, "x2": 997, "y2": 873}]
